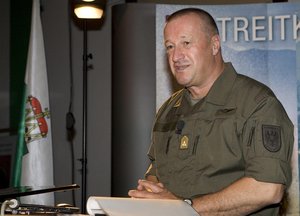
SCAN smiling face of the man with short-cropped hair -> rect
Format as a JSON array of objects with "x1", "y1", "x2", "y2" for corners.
[{"x1": 164, "y1": 13, "x2": 214, "y2": 87}]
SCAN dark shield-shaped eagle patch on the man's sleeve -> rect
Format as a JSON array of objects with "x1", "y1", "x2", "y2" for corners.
[{"x1": 262, "y1": 125, "x2": 281, "y2": 152}]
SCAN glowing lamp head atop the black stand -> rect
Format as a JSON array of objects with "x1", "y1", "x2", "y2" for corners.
[{"x1": 73, "y1": 0, "x2": 105, "y2": 19}]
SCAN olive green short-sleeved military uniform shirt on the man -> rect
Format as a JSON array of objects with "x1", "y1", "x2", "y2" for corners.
[{"x1": 146, "y1": 63, "x2": 294, "y2": 215}]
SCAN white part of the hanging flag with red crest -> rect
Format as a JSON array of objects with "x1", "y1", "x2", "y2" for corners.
[{"x1": 13, "y1": 0, "x2": 54, "y2": 205}]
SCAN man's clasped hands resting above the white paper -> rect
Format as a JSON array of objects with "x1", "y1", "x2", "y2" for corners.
[{"x1": 128, "y1": 180, "x2": 179, "y2": 199}]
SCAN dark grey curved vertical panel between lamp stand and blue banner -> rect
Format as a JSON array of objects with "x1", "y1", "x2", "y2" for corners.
[{"x1": 112, "y1": 3, "x2": 156, "y2": 196}]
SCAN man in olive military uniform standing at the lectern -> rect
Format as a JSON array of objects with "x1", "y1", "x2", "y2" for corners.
[{"x1": 129, "y1": 8, "x2": 294, "y2": 216}]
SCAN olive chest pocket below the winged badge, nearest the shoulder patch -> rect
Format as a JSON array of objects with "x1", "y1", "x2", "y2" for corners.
[{"x1": 194, "y1": 108, "x2": 243, "y2": 173}]
